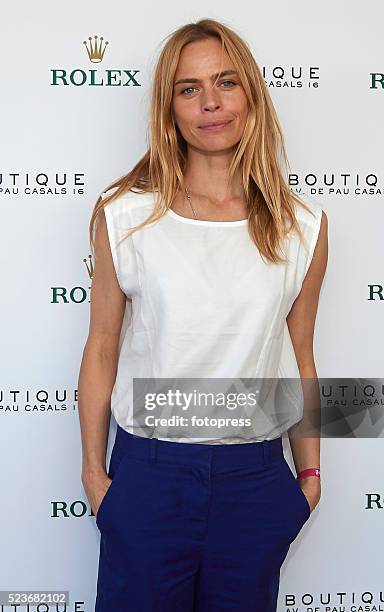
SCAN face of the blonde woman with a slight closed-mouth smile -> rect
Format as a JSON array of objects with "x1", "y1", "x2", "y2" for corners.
[{"x1": 172, "y1": 38, "x2": 248, "y2": 152}]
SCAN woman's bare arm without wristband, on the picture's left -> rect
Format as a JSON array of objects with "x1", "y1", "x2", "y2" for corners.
[{"x1": 78, "y1": 211, "x2": 126, "y2": 514}]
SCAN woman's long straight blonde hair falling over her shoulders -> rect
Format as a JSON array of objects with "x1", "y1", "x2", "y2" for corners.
[{"x1": 89, "y1": 19, "x2": 312, "y2": 263}]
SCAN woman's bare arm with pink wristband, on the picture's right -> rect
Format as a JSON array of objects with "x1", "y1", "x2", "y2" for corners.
[{"x1": 287, "y1": 211, "x2": 328, "y2": 510}]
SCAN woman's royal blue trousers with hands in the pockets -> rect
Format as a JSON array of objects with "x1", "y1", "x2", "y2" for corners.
[{"x1": 95, "y1": 425, "x2": 310, "y2": 612}]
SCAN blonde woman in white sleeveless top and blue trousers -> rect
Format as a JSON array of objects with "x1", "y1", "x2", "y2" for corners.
[{"x1": 79, "y1": 19, "x2": 327, "y2": 612}]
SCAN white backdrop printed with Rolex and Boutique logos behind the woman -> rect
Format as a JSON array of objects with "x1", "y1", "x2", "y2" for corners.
[{"x1": 0, "y1": 0, "x2": 384, "y2": 612}]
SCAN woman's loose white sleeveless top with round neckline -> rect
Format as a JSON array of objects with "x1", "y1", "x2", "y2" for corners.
[{"x1": 101, "y1": 188, "x2": 322, "y2": 444}]
